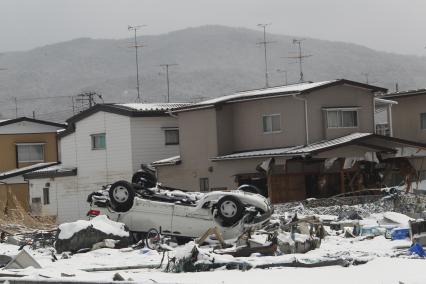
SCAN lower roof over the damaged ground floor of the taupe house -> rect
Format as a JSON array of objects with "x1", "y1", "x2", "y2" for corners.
[{"x1": 211, "y1": 133, "x2": 426, "y2": 161}]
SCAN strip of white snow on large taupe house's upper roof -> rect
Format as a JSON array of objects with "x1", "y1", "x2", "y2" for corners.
[{"x1": 186, "y1": 80, "x2": 337, "y2": 106}]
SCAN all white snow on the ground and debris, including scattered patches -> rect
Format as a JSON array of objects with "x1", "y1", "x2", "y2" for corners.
[{"x1": 0, "y1": 204, "x2": 426, "y2": 284}]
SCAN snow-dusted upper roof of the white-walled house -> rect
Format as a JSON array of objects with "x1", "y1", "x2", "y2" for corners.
[{"x1": 59, "y1": 103, "x2": 190, "y2": 137}]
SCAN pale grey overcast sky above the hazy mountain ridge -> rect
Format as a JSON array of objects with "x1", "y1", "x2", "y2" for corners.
[{"x1": 0, "y1": 0, "x2": 426, "y2": 56}]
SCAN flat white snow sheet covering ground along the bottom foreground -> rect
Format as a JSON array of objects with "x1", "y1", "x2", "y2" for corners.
[{"x1": 0, "y1": 232, "x2": 426, "y2": 284}]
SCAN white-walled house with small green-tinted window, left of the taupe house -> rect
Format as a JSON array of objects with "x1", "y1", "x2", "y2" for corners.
[{"x1": 26, "y1": 103, "x2": 187, "y2": 222}]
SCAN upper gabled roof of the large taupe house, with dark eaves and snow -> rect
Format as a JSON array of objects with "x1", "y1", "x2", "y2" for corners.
[{"x1": 173, "y1": 79, "x2": 387, "y2": 112}]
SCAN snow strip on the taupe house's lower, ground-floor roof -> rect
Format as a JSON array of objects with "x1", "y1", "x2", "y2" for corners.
[{"x1": 212, "y1": 133, "x2": 372, "y2": 161}]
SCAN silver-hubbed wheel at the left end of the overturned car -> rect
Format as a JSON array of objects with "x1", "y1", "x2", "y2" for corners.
[{"x1": 109, "y1": 180, "x2": 135, "y2": 212}]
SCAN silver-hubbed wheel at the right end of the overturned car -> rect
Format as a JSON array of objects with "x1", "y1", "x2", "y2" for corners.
[{"x1": 217, "y1": 195, "x2": 244, "y2": 226}]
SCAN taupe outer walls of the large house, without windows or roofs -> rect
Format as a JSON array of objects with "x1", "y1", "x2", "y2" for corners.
[{"x1": 157, "y1": 81, "x2": 380, "y2": 191}]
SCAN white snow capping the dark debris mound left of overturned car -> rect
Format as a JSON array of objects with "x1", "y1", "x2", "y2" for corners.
[{"x1": 58, "y1": 215, "x2": 129, "y2": 240}]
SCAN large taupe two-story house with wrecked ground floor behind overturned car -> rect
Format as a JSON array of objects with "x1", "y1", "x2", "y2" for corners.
[{"x1": 153, "y1": 80, "x2": 424, "y2": 201}]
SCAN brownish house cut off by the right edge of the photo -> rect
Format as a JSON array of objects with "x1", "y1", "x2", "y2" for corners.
[{"x1": 383, "y1": 89, "x2": 426, "y2": 143}]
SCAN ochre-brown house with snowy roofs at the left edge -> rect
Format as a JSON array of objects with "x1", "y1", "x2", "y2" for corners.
[{"x1": 0, "y1": 117, "x2": 66, "y2": 209}]
